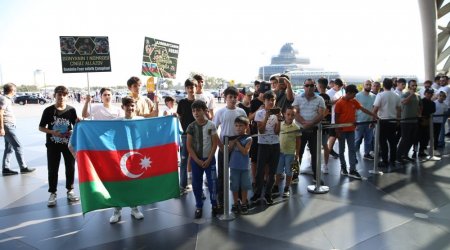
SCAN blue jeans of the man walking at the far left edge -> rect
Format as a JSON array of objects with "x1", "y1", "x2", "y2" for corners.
[{"x1": 2, "y1": 124, "x2": 27, "y2": 169}]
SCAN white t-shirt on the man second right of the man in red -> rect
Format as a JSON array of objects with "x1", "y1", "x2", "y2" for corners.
[{"x1": 373, "y1": 90, "x2": 400, "y2": 119}]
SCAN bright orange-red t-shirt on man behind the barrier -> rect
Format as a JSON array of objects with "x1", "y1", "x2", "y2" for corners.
[{"x1": 334, "y1": 98, "x2": 361, "y2": 132}]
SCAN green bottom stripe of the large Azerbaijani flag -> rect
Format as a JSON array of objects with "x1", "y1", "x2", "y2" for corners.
[{"x1": 80, "y1": 172, "x2": 180, "y2": 213}]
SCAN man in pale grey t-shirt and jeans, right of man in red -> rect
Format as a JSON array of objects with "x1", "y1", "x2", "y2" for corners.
[{"x1": 355, "y1": 80, "x2": 375, "y2": 160}]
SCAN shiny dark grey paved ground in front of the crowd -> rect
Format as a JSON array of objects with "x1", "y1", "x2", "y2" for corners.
[{"x1": 0, "y1": 100, "x2": 450, "y2": 250}]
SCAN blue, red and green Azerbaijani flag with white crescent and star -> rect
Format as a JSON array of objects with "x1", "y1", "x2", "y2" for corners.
[{"x1": 70, "y1": 116, "x2": 180, "y2": 214}]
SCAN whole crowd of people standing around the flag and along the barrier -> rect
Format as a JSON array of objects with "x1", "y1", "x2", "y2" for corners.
[{"x1": 0, "y1": 74, "x2": 450, "y2": 223}]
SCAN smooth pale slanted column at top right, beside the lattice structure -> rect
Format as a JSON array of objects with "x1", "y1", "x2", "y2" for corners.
[{"x1": 418, "y1": 0, "x2": 437, "y2": 80}]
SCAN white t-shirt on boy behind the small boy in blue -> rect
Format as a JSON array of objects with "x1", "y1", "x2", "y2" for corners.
[{"x1": 213, "y1": 107, "x2": 247, "y2": 142}]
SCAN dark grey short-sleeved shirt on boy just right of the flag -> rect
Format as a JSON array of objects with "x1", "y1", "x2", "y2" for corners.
[{"x1": 187, "y1": 120, "x2": 217, "y2": 159}]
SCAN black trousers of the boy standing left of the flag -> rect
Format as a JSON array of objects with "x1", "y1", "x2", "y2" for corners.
[{"x1": 46, "y1": 144, "x2": 75, "y2": 193}]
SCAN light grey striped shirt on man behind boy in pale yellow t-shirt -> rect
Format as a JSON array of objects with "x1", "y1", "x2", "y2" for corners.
[{"x1": 292, "y1": 93, "x2": 325, "y2": 121}]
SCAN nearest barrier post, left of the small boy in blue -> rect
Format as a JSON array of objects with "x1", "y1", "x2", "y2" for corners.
[{"x1": 219, "y1": 136, "x2": 235, "y2": 220}]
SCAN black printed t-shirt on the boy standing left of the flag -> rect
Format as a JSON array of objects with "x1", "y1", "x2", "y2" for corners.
[{"x1": 39, "y1": 105, "x2": 78, "y2": 146}]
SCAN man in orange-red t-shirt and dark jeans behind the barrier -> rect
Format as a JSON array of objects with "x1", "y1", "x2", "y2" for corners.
[{"x1": 334, "y1": 85, "x2": 377, "y2": 179}]
